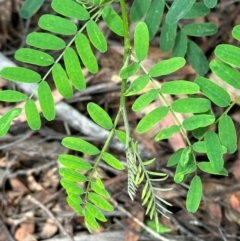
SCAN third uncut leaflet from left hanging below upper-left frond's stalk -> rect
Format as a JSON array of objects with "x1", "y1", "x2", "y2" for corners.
[{"x1": 52, "y1": 63, "x2": 73, "y2": 99}]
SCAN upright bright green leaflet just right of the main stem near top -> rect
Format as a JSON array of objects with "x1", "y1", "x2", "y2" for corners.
[{"x1": 134, "y1": 22, "x2": 149, "y2": 61}]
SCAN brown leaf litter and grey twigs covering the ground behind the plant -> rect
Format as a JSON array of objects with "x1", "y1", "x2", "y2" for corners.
[{"x1": 0, "y1": 0, "x2": 240, "y2": 241}]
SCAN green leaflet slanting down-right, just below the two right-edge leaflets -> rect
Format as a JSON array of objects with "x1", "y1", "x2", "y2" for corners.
[{"x1": 194, "y1": 77, "x2": 231, "y2": 107}]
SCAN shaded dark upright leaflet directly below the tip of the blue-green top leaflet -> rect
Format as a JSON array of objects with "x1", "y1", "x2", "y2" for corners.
[{"x1": 159, "y1": 21, "x2": 177, "y2": 52}]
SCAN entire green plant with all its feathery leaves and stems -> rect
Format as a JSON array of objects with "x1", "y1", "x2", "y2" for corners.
[{"x1": 0, "y1": 0, "x2": 240, "y2": 233}]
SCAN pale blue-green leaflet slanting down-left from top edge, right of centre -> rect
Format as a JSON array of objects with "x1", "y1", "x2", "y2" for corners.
[{"x1": 166, "y1": 0, "x2": 196, "y2": 25}]
